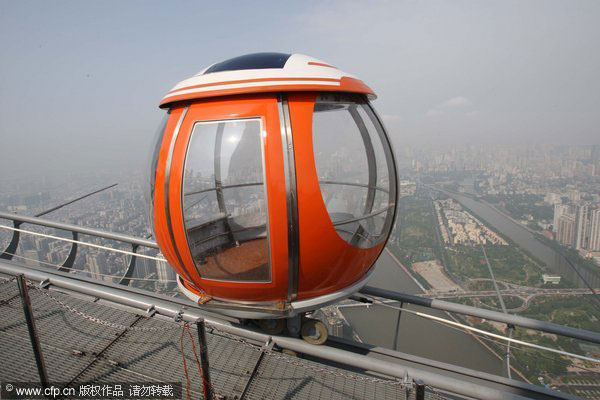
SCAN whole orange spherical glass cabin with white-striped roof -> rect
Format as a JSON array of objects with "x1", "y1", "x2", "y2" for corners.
[{"x1": 150, "y1": 53, "x2": 397, "y2": 318}]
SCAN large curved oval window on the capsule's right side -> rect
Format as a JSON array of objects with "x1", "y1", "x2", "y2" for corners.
[{"x1": 313, "y1": 95, "x2": 396, "y2": 248}]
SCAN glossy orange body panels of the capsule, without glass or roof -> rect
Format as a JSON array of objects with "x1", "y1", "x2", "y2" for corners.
[{"x1": 154, "y1": 92, "x2": 385, "y2": 302}]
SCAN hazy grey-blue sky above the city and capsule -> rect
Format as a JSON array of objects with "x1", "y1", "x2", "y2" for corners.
[{"x1": 0, "y1": 0, "x2": 600, "y2": 178}]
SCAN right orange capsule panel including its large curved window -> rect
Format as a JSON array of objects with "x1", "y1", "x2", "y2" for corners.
[{"x1": 289, "y1": 93, "x2": 396, "y2": 299}]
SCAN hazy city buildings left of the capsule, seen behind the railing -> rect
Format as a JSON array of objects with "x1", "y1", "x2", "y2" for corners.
[{"x1": 0, "y1": 172, "x2": 176, "y2": 291}]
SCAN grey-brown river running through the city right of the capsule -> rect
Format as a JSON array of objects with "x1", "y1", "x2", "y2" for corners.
[{"x1": 342, "y1": 184, "x2": 600, "y2": 375}]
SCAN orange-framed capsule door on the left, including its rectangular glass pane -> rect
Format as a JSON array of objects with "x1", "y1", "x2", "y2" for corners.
[{"x1": 155, "y1": 95, "x2": 288, "y2": 303}]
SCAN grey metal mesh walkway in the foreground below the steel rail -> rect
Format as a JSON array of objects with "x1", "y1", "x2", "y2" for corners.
[{"x1": 0, "y1": 281, "x2": 441, "y2": 399}]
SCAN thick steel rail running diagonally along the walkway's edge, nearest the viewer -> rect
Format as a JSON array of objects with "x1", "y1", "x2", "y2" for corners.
[{"x1": 0, "y1": 261, "x2": 577, "y2": 400}]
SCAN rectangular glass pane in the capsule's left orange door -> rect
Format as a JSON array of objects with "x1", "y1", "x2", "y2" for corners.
[{"x1": 182, "y1": 119, "x2": 271, "y2": 282}]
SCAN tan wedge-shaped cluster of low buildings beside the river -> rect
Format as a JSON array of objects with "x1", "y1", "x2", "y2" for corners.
[{"x1": 433, "y1": 199, "x2": 508, "y2": 245}]
